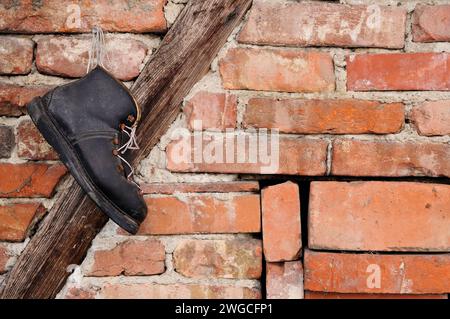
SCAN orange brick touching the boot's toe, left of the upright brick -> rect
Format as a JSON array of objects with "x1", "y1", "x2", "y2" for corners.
[{"x1": 139, "y1": 194, "x2": 261, "y2": 235}]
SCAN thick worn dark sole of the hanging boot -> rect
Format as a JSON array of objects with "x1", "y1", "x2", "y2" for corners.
[{"x1": 27, "y1": 97, "x2": 139, "y2": 234}]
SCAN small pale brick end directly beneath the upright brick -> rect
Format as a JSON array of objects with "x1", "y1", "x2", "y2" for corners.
[{"x1": 266, "y1": 261, "x2": 303, "y2": 299}]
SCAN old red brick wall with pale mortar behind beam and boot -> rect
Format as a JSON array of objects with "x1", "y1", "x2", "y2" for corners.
[{"x1": 0, "y1": 0, "x2": 450, "y2": 298}]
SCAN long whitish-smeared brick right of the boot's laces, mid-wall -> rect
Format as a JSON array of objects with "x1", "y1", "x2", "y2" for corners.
[{"x1": 166, "y1": 132, "x2": 328, "y2": 176}]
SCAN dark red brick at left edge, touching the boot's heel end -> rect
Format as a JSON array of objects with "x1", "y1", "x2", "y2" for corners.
[{"x1": 0, "y1": 84, "x2": 51, "y2": 116}]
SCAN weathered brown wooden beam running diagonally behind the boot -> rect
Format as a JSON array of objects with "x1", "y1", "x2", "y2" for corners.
[{"x1": 2, "y1": 0, "x2": 251, "y2": 298}]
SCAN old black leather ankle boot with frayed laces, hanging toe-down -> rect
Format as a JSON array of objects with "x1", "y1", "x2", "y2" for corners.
[{"x1": 27, "y1": 66, "x2": 147, "y2": 234}]
